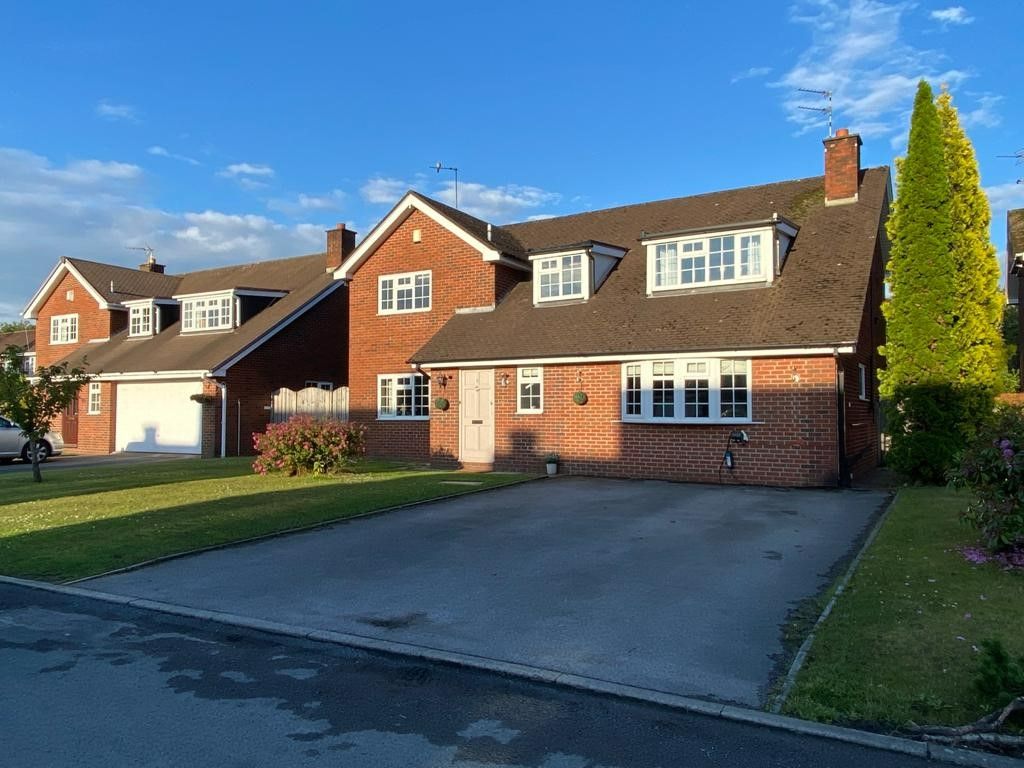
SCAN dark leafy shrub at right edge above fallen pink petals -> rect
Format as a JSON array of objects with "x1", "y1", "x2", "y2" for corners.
[{"x1": 950, "y1": 406, "x2": 1024, "y2": 552}]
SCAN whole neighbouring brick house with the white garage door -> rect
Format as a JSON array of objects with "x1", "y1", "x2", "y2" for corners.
[{"x1": 25, "y1": 224, "x2": 355, "y2": 456}]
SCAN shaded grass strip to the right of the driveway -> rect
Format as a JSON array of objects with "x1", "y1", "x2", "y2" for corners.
[{"x1": 784, "y1": 487, "x2": 1024, "y2": 728}]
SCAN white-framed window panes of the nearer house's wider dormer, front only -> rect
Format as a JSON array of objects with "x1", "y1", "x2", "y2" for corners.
[{"x1": 647, "y1": 229, "x2": 774, "y2": 293}]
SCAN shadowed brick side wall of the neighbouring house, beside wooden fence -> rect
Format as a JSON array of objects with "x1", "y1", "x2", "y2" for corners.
[{"x1": 217, "y1": 286, "x2": 348, "y2": 456}]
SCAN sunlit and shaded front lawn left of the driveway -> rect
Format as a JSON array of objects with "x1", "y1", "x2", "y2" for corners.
[{"x1": 0, "y1": 459, "x2": 526, "y2": 582}]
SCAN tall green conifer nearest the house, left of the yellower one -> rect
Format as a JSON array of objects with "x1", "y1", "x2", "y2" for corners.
[{"x1": 879, "y1": 80, "x2": 959, "y2": 397}]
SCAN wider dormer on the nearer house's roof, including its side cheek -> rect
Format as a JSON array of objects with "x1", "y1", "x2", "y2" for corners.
[{"x1": 642, "y1": 217, "x2": 797, "y2": 295}]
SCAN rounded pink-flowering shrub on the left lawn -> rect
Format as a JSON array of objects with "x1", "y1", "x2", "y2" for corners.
[{"x1": 253, "y1": 416, "x2": 367, "y2": 475}]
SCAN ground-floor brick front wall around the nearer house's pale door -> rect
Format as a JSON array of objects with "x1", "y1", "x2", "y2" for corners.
[{"x1": 430, "y1": 357, "x2": 838, "y2": 486}]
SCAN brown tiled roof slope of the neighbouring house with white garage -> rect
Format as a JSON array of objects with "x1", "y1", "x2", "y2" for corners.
[{"x1": 55, "y1": 253, "x2": 346, "y2": 374}]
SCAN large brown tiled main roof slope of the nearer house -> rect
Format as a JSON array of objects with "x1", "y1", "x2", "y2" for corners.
[{"x1": 412, "y1": 167, "x2": 889, "y2": 362}]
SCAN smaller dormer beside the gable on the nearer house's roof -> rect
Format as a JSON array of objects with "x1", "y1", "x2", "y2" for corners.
[{"x1": 529, "y1": 241, "x2": 628, "y2": 305}]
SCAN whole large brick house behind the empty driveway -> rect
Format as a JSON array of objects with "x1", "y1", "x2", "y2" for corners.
[{"x1": 335, "y1": 130, "x2": 891, "y2": 485}]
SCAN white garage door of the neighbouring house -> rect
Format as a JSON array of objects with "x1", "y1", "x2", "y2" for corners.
[{"x1": 116, "y1": 381, "x2": 203, "y2": 454}]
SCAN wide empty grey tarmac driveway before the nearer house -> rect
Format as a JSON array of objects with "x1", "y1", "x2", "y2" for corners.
[{"x1": 81, "y1": 477, "x2": 886, "y2": 706}]
